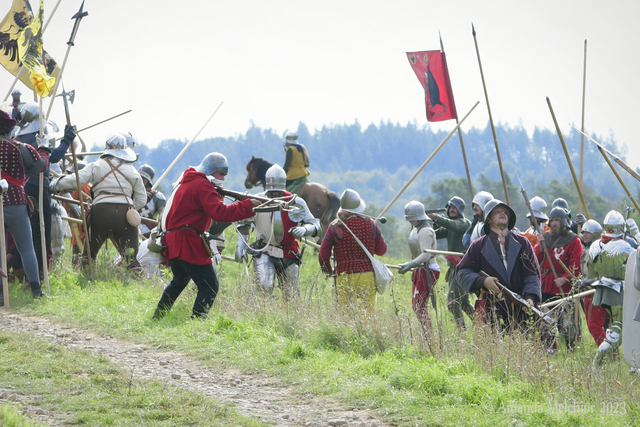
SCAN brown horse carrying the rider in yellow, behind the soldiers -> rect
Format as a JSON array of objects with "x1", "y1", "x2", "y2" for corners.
[{"x1": 244, "y1": 156, "x2": 340, "y2": 239}]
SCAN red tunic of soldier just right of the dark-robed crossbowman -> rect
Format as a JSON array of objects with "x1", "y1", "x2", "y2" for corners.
[{"x1": 535, "y1": 236, "x2": 583, "y2": 295}]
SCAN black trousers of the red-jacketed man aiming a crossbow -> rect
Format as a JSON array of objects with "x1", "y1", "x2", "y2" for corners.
[{"x1": 157, "y1": 258, "x2": 219, "y2": 317}]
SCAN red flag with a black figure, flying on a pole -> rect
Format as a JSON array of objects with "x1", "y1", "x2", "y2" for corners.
[{"x1": 407, "y1": 50, "x2": 458, "y2": 122}]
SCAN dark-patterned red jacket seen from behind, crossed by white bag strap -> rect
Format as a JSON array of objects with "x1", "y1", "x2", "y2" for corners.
[{"x1": 318, "y1": 216, "x2": 387, "y2": 274}]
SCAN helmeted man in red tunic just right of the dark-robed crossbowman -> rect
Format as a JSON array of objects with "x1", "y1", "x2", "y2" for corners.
[{"x1": 535, "y1": 206, "x2": 583, "y2": 353}]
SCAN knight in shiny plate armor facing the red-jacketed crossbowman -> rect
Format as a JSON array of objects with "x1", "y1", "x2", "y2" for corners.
[{"x1": 236, "y1": 165, "x2": 321, "y2": 299}]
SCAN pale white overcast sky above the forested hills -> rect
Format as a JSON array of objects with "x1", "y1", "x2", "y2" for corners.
[{"x1": 5, "y1": 0, "x2": 640, "y2": 167}]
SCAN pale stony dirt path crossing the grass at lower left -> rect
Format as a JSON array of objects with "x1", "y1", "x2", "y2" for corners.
[{"x1": 0, "y1": 309, "x2": 386, "y2": 427}]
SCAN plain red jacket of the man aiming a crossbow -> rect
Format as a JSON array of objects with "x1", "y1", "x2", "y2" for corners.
[{"x1": 164, "y1": 168, "x2": 254, "y2": 265}]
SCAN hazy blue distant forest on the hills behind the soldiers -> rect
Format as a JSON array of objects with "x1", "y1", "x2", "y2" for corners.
[{"x1": 121, "y1": 121, "x2": 638, "y2": 226}]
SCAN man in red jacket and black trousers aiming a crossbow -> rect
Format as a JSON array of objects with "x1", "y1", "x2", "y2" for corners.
[{"x1": 153, "y1": 153, "x2": 260, "y2": 319}]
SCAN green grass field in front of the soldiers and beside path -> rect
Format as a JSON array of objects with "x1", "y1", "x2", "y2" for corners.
[{"x1": 0, "y1": 234, "x2": 640, "y2": 427}]
